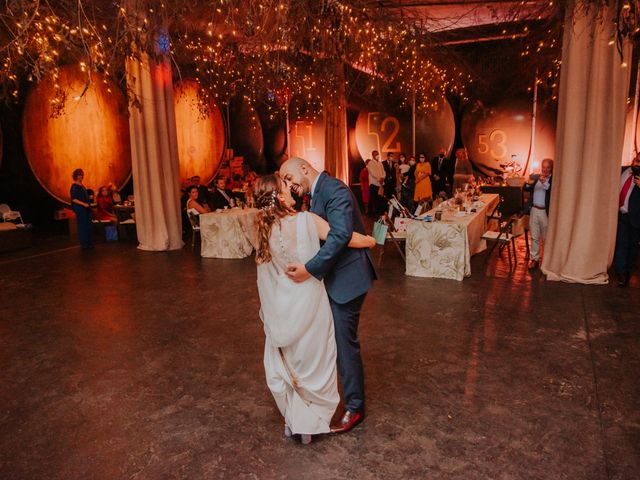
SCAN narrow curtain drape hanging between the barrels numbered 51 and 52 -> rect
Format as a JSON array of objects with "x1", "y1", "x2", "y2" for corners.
[{"x1": 324, "y1": 63, "x2": 349, "y2": 185}]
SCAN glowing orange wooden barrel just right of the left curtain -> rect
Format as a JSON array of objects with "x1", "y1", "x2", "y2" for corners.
[{"x1": 174, "y1": 80, "x2": 225, "y2": 184}]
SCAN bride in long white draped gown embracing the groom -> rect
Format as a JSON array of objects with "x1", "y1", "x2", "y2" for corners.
[{"x1": 254, "y1": 175, "x2": 375, "y2": 444}]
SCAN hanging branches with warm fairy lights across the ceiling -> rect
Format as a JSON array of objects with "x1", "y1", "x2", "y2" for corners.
[{"x1": 0, "y1": 0, "x2": 640, "y2": 117}]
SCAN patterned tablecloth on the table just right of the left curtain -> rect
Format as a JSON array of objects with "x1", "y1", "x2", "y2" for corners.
[{"x1": 200, "y1": 208, "x2": 258, "y2": 258}]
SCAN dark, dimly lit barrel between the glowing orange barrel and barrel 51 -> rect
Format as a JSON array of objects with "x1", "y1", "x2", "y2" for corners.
[{"x1": 230, "y1": 100, "x2": 266, "y2": 173}]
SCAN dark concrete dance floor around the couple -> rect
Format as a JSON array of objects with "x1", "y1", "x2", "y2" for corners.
[{"x1": 0, "y1": 238, "x2": 640, "y2": 480}]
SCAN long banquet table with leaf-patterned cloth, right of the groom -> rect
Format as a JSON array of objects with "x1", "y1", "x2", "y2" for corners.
[{"x1": 405, "y1": 194, "x2": 500, "y2": 281}]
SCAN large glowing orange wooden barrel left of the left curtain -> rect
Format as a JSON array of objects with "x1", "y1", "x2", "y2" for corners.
[{"x1": 22, "y1": 65, "x2": 131, "y2": 203}]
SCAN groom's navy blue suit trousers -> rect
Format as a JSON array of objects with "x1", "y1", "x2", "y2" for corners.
[{"x1": 329, "y1": 293, "x2": 367, "y2": 412}]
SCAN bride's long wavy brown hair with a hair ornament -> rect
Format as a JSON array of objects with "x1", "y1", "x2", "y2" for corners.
[{"x1": 253, "y1": 174, "x2": 293, "y2": 265}]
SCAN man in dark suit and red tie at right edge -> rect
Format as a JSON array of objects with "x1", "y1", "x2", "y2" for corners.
[{"x1": 614, "y1": 155, "x2": 640, "y2": 287}]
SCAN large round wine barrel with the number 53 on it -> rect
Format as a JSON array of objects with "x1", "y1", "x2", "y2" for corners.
[{"x1": 462, "y1": 98, "x2": 555, "y2": 176}]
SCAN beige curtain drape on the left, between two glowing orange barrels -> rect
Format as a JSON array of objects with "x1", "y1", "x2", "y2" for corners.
[{"x1": 126, "y1": 54, "x2": 183, "y2": 251}]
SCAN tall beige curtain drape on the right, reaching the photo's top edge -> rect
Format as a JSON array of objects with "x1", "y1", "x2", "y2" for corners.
[{"x1": 542, "y1": 1, "x2": 631, "y2": 284}]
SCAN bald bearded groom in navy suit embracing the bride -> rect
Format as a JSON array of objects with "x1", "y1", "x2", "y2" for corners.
[{"x1": 280, "y1": 157, "x2": 376, "y2": 433}]
